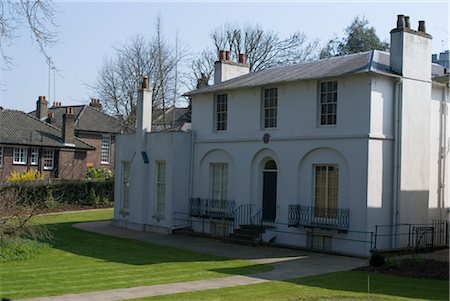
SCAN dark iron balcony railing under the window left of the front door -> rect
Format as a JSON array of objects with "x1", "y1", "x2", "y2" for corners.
[{"x1": 189, "y1": 198, "x2": 234, "y2": 219}]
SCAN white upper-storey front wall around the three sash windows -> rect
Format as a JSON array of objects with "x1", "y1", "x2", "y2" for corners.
[{"x1": 192, "y1": 74, "x2": 371, "y2": 141}]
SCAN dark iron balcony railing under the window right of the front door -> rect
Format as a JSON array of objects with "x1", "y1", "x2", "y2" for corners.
[{"x1": 288, "y1": 205, "x2": 350, "y2": 232}]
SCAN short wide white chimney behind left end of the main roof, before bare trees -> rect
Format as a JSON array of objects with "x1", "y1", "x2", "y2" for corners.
[{"x1": 214, "y1": 50, "x2": 250, "y2": 84}]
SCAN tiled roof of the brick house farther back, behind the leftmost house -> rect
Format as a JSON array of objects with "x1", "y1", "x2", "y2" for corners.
[{"x1": 29, "y1": 105, "x2": 121, "y2": 134}]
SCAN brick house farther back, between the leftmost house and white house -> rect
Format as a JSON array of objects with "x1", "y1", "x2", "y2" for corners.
[{"x1": 29, "y1": 96, "x2": 121, "y2": 170}]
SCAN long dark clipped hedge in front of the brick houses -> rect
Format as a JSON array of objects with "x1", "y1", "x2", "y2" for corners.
[{"x1": 0, "y1": 180, "x2": 114, "y2": 207}]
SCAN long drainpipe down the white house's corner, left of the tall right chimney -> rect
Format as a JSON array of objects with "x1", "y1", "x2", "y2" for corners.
[{"x1": 391, "y1": 77, "x2": 403, "y2": 248}]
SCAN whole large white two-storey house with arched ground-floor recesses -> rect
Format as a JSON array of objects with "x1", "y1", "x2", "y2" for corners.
[{"x1": 113, "y1": 15, "x2": 450, "y2": 255}]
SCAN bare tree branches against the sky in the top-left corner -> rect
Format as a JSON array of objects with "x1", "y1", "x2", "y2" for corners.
[{"x1": 0, "y1": 0, "x2": 56, "y2": 66}]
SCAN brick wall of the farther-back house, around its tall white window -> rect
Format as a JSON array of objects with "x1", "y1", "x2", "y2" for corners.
[{"x1": 76, "y1": 132, "x2": 116, "y2": 170}]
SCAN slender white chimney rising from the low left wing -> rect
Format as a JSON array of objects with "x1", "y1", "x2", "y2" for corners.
[{"x1": 136, "y1": 76, "x2": 152, "y2": 136}]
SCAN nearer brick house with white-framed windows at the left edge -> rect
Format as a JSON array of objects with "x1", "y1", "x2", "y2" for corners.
[{"x1": 0, "y1": 107, "x2": 95, "y2": 182}]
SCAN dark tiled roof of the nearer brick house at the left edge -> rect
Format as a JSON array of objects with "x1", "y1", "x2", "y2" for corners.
[{"x1": 0, "y1": 109, "x2": 95, "y2": 150}]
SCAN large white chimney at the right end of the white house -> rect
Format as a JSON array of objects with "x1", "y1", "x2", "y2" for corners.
[{"x1": 390, "y1": 15, "x2": 432, "y2": 81}]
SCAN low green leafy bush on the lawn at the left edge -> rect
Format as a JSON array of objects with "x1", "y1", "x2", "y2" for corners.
[{"x1": 0, "y1": 236, "x2": 48, "y2": 262}]
